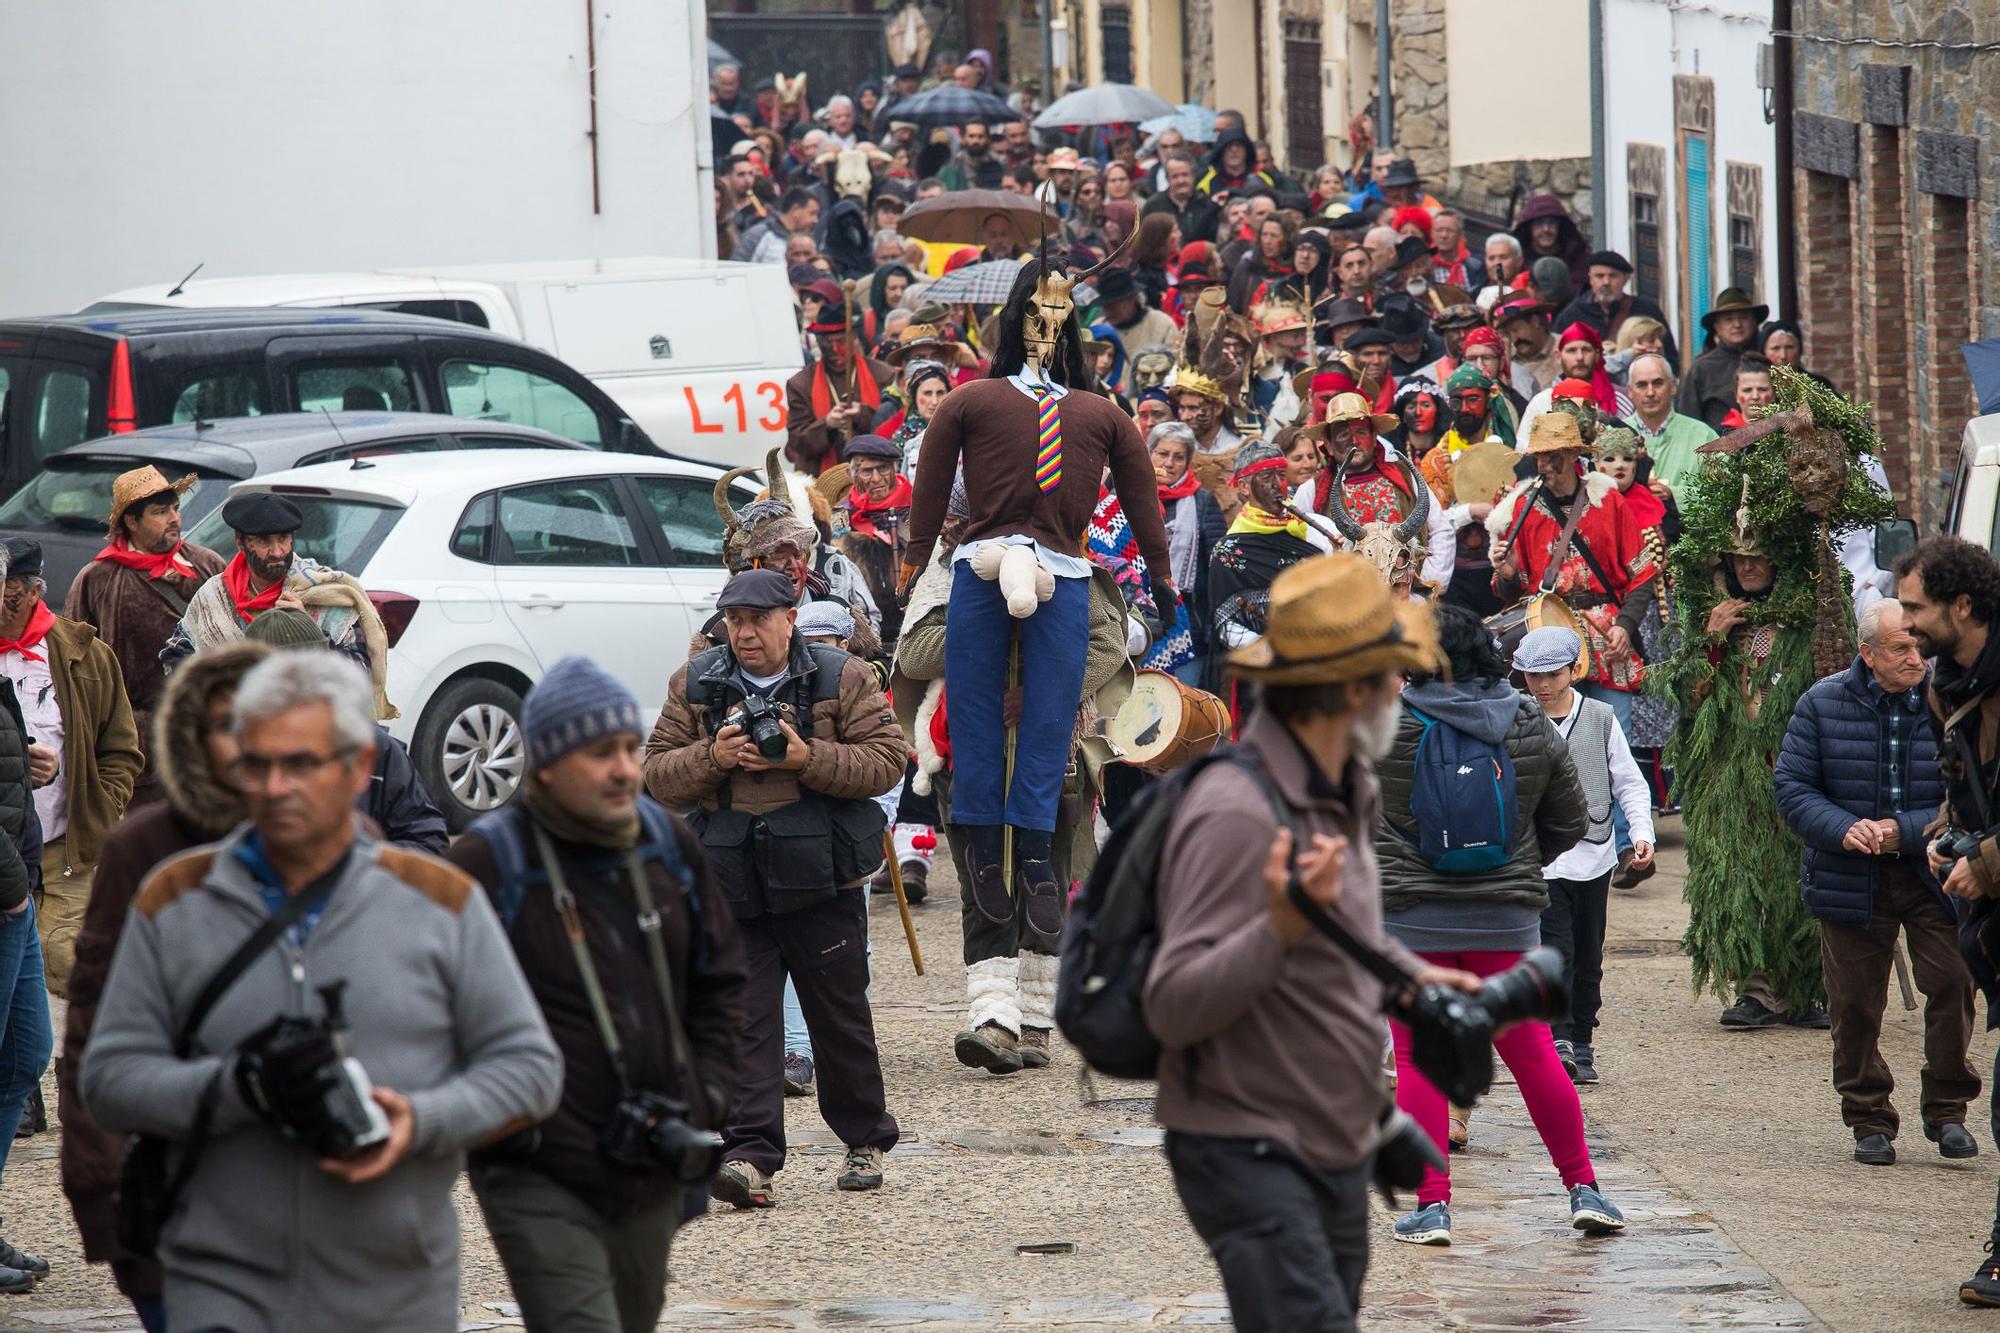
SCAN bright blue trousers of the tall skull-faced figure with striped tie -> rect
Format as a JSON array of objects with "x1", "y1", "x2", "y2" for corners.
[{"x1": 944, "y1": 560, "x2": 1090, "y2": 833}]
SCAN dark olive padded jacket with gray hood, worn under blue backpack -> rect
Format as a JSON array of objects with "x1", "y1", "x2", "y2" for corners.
[{"x1": 1376, "y1": 681, "x2": 1590, "y2": 953}]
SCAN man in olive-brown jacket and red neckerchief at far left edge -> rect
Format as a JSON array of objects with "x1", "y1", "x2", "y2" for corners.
[{"x1": 0, "y1": 536, "x2": 146, "y2": 995}]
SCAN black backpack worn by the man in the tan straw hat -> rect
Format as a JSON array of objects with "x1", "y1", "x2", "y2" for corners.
[{"x1": 1056, "y1": 749, "x2": 1292, "y2": 1079}]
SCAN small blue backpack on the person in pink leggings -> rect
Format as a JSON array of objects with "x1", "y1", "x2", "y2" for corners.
[{"x1": 1404, "y1": 705, "x2": 1518, "y2": 875}]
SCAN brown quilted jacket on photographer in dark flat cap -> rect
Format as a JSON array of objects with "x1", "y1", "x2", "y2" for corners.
[{"x1": 646, "y1": 634, "x2": 910, "y2": 815}]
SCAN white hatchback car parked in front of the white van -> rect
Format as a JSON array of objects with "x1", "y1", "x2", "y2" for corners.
[{"x1": 188, "y1": 450, "x2": 756, "y2": 831}]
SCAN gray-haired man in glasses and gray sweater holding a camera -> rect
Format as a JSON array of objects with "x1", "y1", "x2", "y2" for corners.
[{"x1": 80, "y1": 652, "x2": 562, "y2": 1333}]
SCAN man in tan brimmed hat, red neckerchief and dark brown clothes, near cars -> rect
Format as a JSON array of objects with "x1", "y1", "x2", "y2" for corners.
[{"x1": 62, "y1": 462, "x2": 222, "y2": 801}]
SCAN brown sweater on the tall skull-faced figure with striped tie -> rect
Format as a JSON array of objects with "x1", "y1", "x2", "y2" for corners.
[{"x1": 902, "y1": 380, "x2": 1174, "y2": 578}]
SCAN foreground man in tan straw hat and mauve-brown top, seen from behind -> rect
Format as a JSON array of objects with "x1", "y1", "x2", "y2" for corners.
[{"x1": 1144, "y1": 554, "x2": 1478, "y2": 1331}]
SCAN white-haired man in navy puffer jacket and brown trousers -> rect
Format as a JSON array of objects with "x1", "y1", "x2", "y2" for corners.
[{"x1": 1776, "y1": 600, "x2": 1980, "y2": 1167}]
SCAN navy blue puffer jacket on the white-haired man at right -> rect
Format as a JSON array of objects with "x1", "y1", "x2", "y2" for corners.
[{"x1": 1774, "y1": 656, "x2": 1950, "y2": 927}]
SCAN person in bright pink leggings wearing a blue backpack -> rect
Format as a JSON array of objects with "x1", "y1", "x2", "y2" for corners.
[{"x1": 1376, "y1": 606, "x2": 1624, "y2": 1245}]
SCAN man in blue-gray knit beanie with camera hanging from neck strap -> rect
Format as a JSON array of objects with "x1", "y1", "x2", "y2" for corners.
[{"x1": 448, "y1": 656, "x2": 744, "y2": 1333}]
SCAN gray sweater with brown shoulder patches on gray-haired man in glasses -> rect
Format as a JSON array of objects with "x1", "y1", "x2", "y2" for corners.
[{"x1": 82, "y1": 827, "x2": 562, "y2": 1333}]
